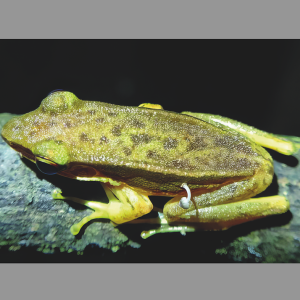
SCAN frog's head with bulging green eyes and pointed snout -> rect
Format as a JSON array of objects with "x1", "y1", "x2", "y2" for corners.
[{"x1": 1, "y1": 91, "x2": 80, "y2": 174}]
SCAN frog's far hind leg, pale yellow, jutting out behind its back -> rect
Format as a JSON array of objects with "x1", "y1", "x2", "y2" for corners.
[{"x1": 182, "y1": 112, "x2": 298, "y2": 155}]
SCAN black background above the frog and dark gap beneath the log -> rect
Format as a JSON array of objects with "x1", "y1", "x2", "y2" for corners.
[{"x1": 0, "y1": 40, "x2": 300, "y2": 261}]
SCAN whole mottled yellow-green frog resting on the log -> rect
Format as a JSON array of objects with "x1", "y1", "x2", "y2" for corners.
[{"x1": 1, "y1": 90, "x2": 299, "y2": 238}]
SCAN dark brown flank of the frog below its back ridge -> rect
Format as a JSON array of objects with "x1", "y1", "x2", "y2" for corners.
[{"x1": 60, "y1": 157, "x2": 273, "y2": 196}]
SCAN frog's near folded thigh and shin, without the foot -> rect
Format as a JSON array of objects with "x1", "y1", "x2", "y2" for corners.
[{"x1": 164, "y1": 159, "x2": 289, "y2": 229}]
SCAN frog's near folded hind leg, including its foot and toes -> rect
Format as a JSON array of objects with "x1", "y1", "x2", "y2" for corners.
[{"x1": 138, "y1": 179, "x2": 289, "y2": 239}]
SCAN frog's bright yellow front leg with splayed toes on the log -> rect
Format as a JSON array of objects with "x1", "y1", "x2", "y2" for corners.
[{"x1": 53, "y1": 183, "x2": 153, "y2": 235}]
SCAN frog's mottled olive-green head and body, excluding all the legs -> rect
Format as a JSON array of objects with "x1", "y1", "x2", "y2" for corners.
[{"x1": 2, "y1": 92, "x2": 273, "y2": 196}]
